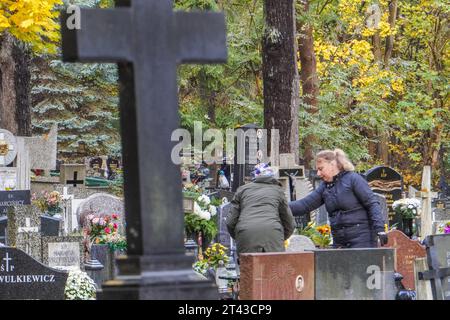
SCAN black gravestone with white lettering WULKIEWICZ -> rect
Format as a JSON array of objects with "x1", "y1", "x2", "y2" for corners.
[{"x1": 0, "y1": 247, "x2": 68, "y2": 300}]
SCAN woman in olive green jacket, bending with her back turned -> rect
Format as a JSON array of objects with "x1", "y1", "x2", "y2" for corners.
[{"x1": 226, "y1": 164, "x2": 294, "y2": 253}]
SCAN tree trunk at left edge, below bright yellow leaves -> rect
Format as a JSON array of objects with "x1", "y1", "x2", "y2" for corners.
[{"x1": 0, "y1": 33, "x2": 31, "y2": 136}]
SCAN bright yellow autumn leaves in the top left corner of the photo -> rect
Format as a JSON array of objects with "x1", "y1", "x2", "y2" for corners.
[{"x1": 0, "y1": 0, "x2": 63, "y2": 53}]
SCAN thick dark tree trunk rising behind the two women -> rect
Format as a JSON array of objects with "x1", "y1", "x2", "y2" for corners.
[{"x1": 263, "y1": 0, "x2": 300, "y2": 159}]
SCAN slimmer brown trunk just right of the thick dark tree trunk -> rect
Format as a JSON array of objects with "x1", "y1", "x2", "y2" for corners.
[{"x1": 298, "y1": 0, "x2": 319, "y2": 169}]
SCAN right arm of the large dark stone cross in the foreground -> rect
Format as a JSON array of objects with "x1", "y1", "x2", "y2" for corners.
[{"x1": 175, "y1": 11, "x2": 227, "y2": 63}]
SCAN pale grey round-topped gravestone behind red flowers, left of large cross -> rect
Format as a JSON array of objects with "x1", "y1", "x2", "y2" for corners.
[{"x1": 76, "y1": 193, "x2": 125, "y2": 233}]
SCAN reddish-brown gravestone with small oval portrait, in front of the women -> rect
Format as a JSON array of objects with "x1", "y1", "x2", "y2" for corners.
[{"x1": 239, "y1": 252, "x2": 315, "y2": 300}]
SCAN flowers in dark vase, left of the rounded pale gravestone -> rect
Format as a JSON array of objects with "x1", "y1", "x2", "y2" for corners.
[{"x1": 31, "y1": 191, "x2": 63, "y2": 236}]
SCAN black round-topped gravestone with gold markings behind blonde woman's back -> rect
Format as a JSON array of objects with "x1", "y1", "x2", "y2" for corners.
[{"x1": 365, "y1": 166, "x2": 403, "y2": 226}]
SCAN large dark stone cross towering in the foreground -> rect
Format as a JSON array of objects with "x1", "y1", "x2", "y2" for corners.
[{"x1": 62, "y1": 0, "x2": 227, "y2": 298}]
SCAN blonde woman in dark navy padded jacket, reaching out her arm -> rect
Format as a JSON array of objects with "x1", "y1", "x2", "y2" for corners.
[{"x1": 289, "y1": 149, "x2": 387, "y2": 248}]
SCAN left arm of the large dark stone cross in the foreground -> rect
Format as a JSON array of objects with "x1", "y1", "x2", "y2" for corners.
[{"x1": 61, "y1": 8, "x2": 133, "y2": 62}]
